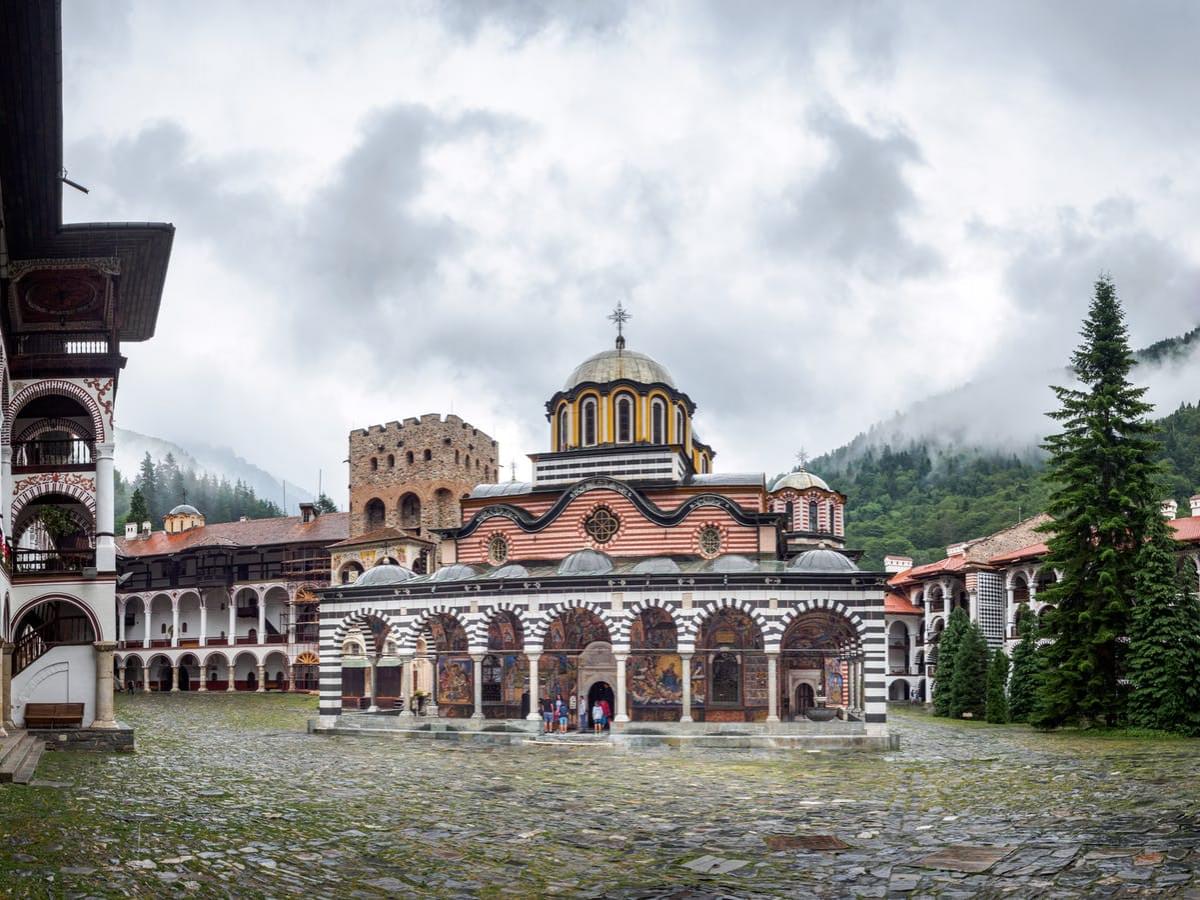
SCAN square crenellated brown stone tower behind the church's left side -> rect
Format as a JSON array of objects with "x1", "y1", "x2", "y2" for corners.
[{"x1": 350, "y1": 413, "x2": 499, "y2": 538}]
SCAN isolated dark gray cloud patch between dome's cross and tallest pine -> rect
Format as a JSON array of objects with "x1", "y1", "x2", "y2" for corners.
[{"x1": 764, "y1": 109, "x2": 941, "y2": 280}]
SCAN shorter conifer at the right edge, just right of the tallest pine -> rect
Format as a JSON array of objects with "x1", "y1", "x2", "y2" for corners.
[{"x1": 1129, "y1": 516, "x2": 1200, "y2": 734}]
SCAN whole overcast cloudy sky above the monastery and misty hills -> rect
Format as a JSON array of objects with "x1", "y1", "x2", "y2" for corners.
[{"x1": 62, "y1": 0, "x2": 1200, "y2": 502}]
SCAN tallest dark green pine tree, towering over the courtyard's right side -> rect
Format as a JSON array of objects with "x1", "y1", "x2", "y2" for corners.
[{"x1": 1031, "y1": 277, "x2": 1160, "y2": 727}]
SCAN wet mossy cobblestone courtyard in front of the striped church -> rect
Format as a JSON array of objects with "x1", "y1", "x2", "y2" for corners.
[{"x1": 0, "y1": 695, "x2": 1200, "y2": 896}]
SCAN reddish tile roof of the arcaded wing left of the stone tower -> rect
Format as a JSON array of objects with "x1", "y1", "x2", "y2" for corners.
[{"x1": 116, "y1": 512, "x2": 350, "y2": 557}]
